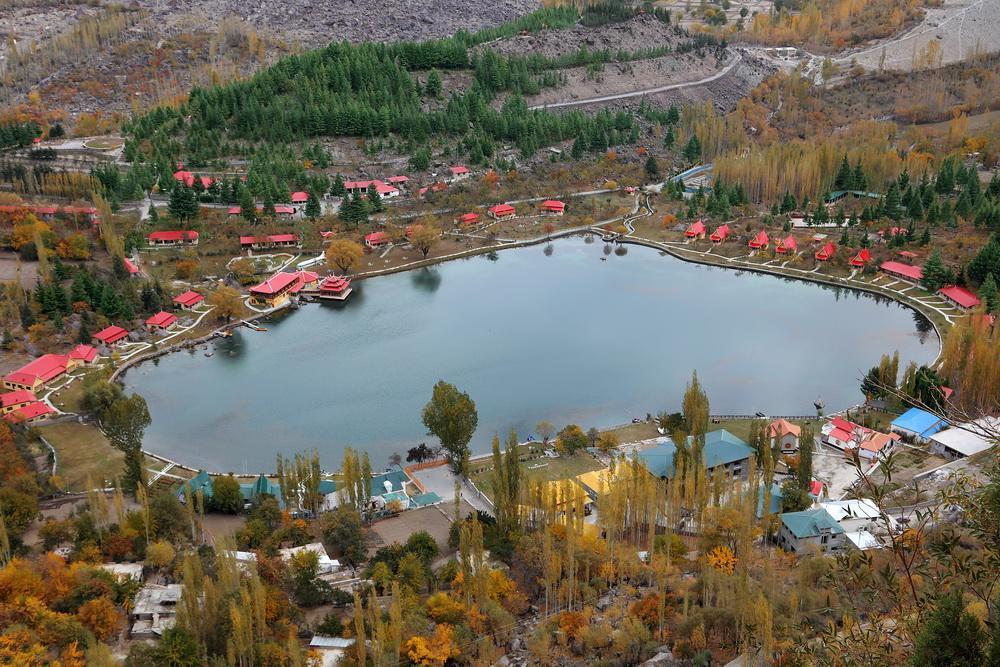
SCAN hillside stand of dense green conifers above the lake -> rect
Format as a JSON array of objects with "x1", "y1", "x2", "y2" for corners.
[{"x1": 125, "y1": 7, "x2": 718, "y2": 194}]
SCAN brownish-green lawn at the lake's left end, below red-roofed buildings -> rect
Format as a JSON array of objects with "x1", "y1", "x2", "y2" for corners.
[{"x1": 38, "y1": 422, "x2": 122, "y2": 491}]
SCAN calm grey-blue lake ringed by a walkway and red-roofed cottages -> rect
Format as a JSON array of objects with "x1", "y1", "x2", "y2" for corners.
[{"x1": 123, "y1": 238, "x2": 939, "y2": 472}]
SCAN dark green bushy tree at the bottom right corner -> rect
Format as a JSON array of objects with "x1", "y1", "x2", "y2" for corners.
[{"x1": 910, "y1": 590, "x2": 985, "y2": 667}]
